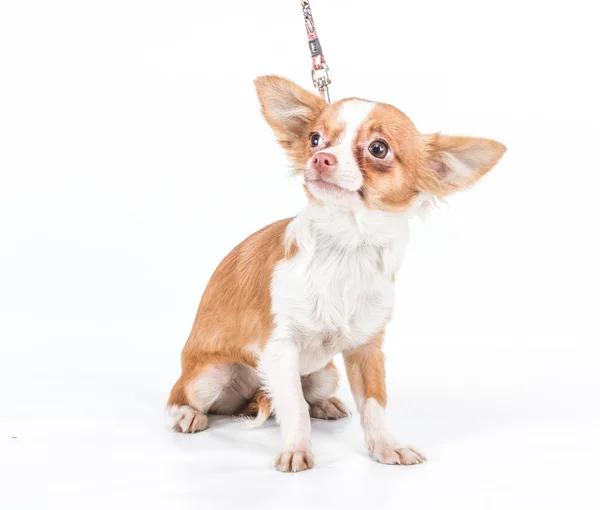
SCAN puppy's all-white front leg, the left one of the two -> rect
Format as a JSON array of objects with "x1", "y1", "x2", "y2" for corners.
[{"x1": 260, "y1": 338, "x2": 313, "y2": 472}]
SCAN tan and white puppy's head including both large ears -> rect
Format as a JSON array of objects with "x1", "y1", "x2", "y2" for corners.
[{"x1": 255, "y1": 76, "x2": 506, "y2": 212}]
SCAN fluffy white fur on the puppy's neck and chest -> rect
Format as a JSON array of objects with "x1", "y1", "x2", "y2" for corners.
[{"x1": 271, "y1": 206, "x2": 408, "y2": 374}]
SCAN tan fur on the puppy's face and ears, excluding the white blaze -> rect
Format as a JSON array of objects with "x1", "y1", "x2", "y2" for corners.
[{"x1": 255, "y1": 76, "x2": 506, "y2": 212}]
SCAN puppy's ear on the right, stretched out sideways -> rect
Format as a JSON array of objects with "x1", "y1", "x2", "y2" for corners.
[{"x1": 417, "y1": 134, "x2": 506, "y2": 197}]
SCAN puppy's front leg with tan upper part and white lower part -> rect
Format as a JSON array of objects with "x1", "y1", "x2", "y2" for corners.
[{"x1": 344, "y1": 335, "x2": 426, "y2": 464}]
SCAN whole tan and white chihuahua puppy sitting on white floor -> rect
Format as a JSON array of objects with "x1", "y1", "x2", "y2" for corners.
[{"x1": 168, "y1": 76, "x2": 506, "y2": 472}]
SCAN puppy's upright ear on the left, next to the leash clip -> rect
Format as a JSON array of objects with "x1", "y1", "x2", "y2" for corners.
[{"x1": 254, "y1": 76, "x2": 326, "y2": 152}]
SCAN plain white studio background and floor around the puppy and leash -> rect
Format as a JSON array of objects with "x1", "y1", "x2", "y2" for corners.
[{"x1": 0, "y1": 0, "x2": 600, "y2": 510}]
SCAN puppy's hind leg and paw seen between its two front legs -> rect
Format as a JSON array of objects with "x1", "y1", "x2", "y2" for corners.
[{"x1": 302, "y1": 361, "x2": 350, "y2": 420}]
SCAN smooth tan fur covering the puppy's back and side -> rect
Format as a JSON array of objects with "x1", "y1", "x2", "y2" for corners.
[{"x1": 168, "y1": 218, "x2": 298, "y2": 406}]
